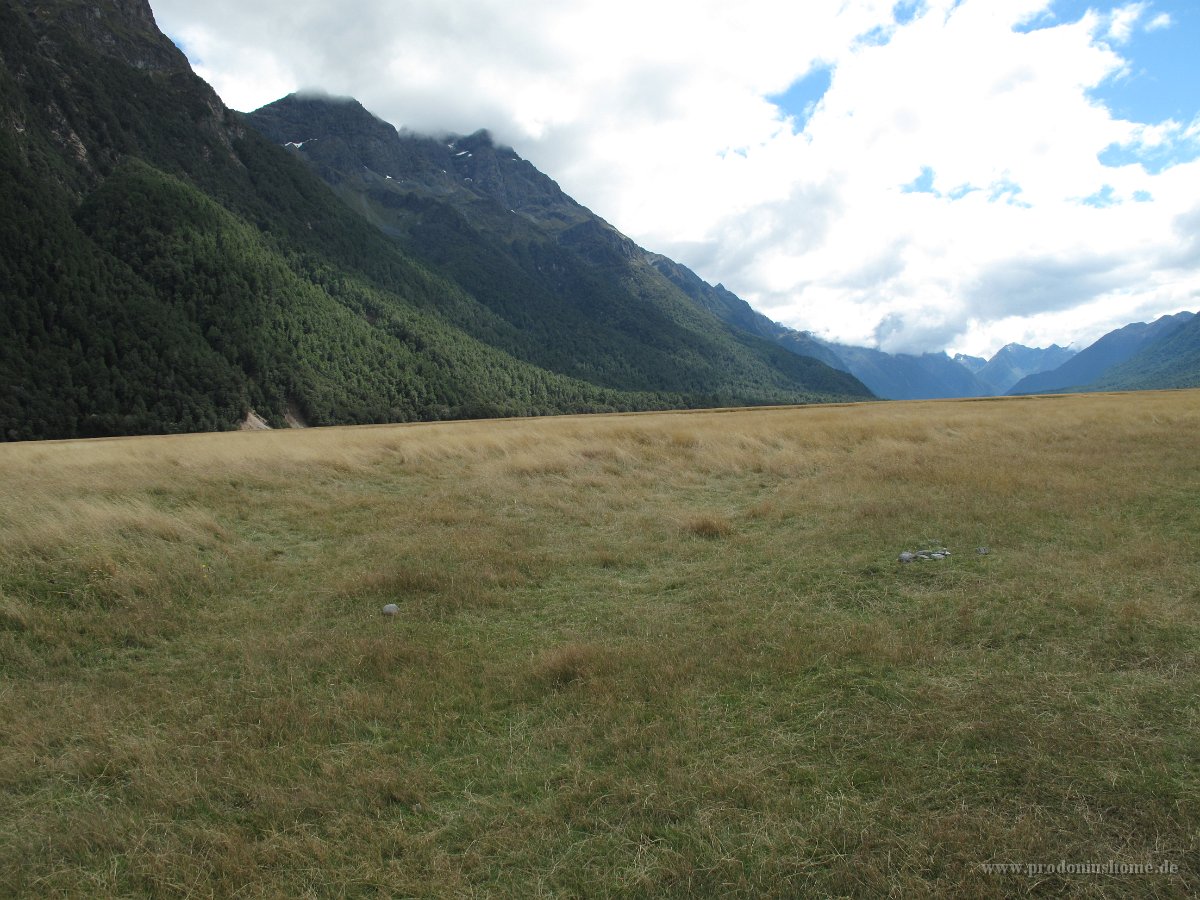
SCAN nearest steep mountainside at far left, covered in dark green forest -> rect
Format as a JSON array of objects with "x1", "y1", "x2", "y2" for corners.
[{"x1": 0, "y1": 0, "x2": 862, "y2": 439}]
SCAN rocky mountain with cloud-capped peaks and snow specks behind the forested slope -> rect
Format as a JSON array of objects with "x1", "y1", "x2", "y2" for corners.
[{"x1": 247, "y1": 95, "x2": 868, "y2": 403}]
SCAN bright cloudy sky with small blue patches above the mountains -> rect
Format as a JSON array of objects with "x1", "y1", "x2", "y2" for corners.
[{"x1": 150, "y1": 0, "x2": 1200, "y2": 356}]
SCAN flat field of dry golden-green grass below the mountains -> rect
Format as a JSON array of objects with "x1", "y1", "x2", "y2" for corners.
[{"x1": 0, "y1": 391, "x2": 1200, "y2": 898}]
